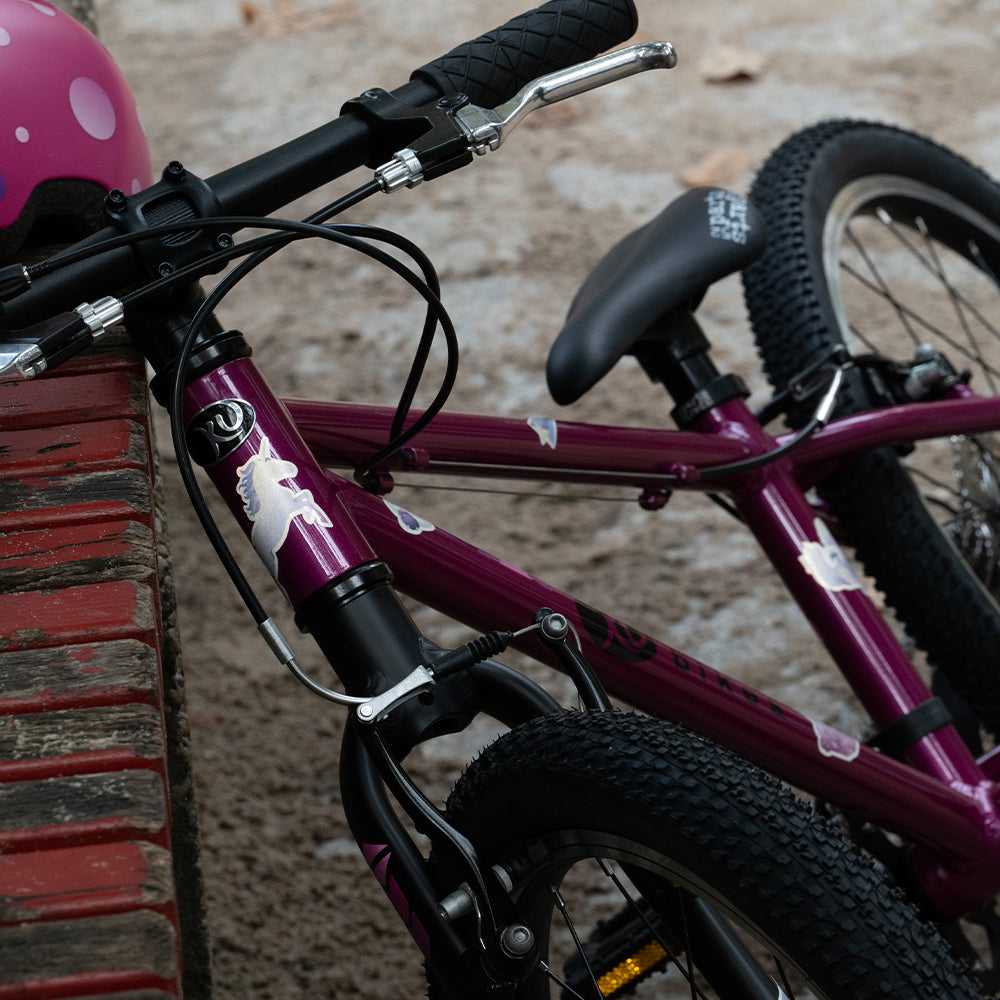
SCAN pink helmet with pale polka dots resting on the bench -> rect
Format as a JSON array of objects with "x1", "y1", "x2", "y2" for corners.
[{"x1": 0, "y1": 0, "x2": 152, "y2": 259}]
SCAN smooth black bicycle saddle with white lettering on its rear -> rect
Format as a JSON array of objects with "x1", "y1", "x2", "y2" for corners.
[{"x1": 545, "y1": 188, "x2": 767, "y2": 405}]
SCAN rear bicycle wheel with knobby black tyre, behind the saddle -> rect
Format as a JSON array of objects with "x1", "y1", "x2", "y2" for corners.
[{"x1": 744, "y1": 121, "x2": 1000, "y2": 736}]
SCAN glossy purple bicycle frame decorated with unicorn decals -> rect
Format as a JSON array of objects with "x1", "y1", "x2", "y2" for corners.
[{"x1": 185, "y1": 359, "x2": 1000, "y2": 914}]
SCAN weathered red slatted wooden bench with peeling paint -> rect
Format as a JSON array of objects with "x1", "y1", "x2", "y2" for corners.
[{"x1": 0, "y1": 342, "x2": 207, "y2": 1000}]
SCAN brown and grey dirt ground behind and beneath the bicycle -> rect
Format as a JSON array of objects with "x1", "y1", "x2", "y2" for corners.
[{"x1": 99, "y1": 0, "x2": 1000, "y2": 1000}]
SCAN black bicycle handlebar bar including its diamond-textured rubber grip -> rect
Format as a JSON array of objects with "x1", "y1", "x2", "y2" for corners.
[{"x1": 0, "y1": 0, "x2": 638, "y2": 330}]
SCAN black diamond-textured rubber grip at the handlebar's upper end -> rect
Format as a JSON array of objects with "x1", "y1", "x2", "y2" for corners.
[{"x1": 410, "y1": 0, "x2": 639, "y2": 108}]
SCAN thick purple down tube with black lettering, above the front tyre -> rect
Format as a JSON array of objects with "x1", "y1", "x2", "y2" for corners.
[{"x1": 343, "y1": 490, "x2": 982, "y2": 855}]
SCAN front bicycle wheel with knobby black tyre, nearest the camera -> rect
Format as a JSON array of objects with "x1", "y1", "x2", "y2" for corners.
[{"x1": 431, "y1": 713, "x2": 979, "y2": 1000}]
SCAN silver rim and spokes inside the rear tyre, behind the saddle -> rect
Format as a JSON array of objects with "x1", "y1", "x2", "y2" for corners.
[{"x1": 822, "y1": 174, "x2": 1000, "y2": 599}]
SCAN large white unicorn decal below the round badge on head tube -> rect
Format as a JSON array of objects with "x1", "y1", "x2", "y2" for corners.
[{"x1": 236, "y1": 438, "x2": 333, "y2": 577}]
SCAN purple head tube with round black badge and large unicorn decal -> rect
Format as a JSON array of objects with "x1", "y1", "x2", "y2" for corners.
[{"x1": 178, "y1": 358, "x2": 375, "y2": 607}]
